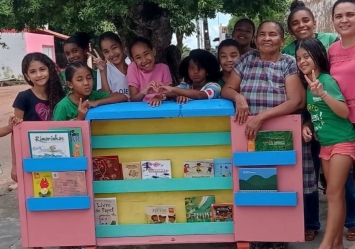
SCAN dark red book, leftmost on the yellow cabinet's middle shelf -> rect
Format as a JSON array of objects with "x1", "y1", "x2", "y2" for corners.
[{"x1": 92, "y1": 156, "x2": 123, "y2": 181}]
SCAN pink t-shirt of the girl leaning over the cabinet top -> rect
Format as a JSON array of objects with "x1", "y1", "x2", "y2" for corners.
[{"x1": 127, "y1": 62, "x2": 173, "y2": 102}]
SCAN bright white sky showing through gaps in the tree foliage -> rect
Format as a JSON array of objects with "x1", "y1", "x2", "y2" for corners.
[{"x1": 171, "y1": 13, "x2": 231, "y2": 49}]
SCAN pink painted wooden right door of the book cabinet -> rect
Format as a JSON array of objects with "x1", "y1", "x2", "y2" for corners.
[{"x1": 231, "y1": 115, "x2": 304, "y2": 242}]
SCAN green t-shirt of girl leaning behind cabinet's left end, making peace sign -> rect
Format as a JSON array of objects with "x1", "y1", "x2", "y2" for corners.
[{"x1": 53, "y1": 91, "x2": 110, "y2": 121}]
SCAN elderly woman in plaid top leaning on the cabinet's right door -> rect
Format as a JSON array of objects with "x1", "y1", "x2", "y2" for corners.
[{"x1": 222, "y1": 21, "x2": 305, "y2": 249}]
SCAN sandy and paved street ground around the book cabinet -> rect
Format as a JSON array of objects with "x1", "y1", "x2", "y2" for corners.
[{"x1": 0, "y1": 85, "x2": 350, "y2": 249}]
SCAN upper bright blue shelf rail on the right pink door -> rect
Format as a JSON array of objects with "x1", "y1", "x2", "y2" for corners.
[{"x1": 233, "y1": 150, "x2": 296, "y2": 167}]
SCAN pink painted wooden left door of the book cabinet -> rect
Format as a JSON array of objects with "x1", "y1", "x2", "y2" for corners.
[{"x1": 14, "y1": 121, "x2": 96, "y2": 247}]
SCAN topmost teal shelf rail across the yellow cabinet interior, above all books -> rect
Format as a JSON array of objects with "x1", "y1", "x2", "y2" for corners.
[{"x1": 91, "y1": 132, "x2": 231, "y2": 149}]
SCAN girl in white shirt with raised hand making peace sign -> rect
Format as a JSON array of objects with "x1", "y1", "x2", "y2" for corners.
[{"x1": 93, "y1": 31, "x2": 129, "y2": 97}]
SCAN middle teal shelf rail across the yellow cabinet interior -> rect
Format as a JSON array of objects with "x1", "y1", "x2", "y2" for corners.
[{"x1": 94, "y1": 177, "x2": 232, "y2": 194}]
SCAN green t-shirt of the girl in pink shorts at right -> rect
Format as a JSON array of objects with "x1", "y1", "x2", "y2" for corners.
[{"x1": 307, "y1": 74, "x2": 355, "y2": 146}]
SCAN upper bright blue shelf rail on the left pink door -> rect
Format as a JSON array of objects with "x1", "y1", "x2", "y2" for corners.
[{"x1": 23, "y1": 157, "x2": 88, "y2": 172}]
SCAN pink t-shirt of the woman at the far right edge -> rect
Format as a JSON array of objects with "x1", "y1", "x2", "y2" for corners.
[{"x1": 329, "y1": 41, "x2": 355, "y2": 123}]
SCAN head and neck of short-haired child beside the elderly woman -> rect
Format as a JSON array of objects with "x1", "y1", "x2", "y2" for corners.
[{"x1": 217, "y1": 39, "x2": 240, "y2": 88}]
